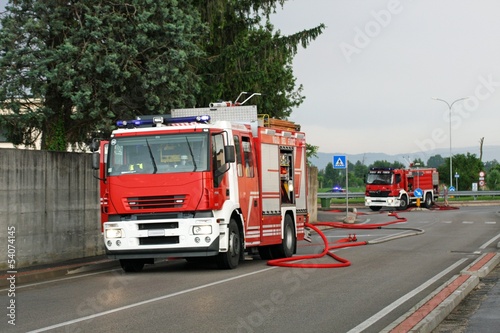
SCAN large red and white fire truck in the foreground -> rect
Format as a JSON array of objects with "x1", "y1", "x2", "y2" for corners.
[{"x1": 93, "y1": 95, "x2": 309, "y2": 272}]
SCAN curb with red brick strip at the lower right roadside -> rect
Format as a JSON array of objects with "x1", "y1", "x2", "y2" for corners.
[{"x1": 382, "y1": 252, "x2": 500, "y2": 333}]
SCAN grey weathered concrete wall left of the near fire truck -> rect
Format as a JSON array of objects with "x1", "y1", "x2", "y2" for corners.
[{"x1": 0, "y1": 149, "x2": 104, "y2": 269}]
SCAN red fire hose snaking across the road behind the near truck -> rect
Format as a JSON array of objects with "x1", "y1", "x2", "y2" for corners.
[{"x1": 267, "y1": 213, "x2": 425, "y2": 268}]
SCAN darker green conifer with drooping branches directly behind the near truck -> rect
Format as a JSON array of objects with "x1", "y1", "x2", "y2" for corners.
[{"x1": 191, "y1": 0, "x2": 325, "y2": 119}]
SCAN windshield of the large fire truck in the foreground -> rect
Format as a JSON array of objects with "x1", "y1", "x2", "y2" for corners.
[{"x1": 107, "y1": 133, "x2": 209, "y2": 176}]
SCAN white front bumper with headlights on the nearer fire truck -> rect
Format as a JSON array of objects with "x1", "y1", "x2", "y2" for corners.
[{"x1": 103, "y1": 218, "x2": 220, "y2": 259}]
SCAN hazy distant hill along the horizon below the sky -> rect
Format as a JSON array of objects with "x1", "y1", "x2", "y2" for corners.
[{"x1": 311, "y1": 146, "x2": 500, "y2": 170}]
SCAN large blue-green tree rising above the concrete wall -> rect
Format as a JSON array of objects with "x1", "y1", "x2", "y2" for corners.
[{"x1": 0, "y1": 0, "x2": 204, "y2": 150}]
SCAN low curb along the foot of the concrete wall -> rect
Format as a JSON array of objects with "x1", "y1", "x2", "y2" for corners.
[{"x1": 0, "y1": 258, "x2": 120, "y2": 288}]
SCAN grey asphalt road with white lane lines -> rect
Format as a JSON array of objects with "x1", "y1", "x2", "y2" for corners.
[{"x1": 0, "y1": 206, "x2": 500, "y2": 333}]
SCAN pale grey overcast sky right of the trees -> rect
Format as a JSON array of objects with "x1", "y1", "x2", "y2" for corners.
[{"x1": 272, "y1": 0, "x2": 500, "y2": 159}]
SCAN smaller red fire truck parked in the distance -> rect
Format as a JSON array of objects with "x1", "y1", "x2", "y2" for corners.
[{"x1": 365, "y1": 168, "x2": 439, "y2": 211}]
